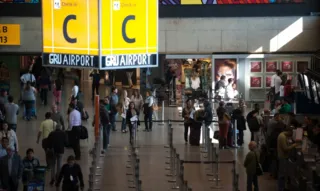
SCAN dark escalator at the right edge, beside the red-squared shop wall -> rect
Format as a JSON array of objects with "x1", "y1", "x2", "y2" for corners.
[{"x1": 295, "y1": 51, "x2": 320, "y2": 114}]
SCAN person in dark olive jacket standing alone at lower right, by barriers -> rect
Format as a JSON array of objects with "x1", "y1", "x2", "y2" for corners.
[{"x1": 244, "y1": 141, "x2": 260, "y2": 191}]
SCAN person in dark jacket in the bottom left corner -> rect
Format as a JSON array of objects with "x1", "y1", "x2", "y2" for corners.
[{"x1": 0, "y1": 147, "x2": 23, "y2": 191}]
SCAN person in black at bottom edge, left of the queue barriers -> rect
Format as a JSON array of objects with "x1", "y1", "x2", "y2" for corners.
[{"x1": 56, "y1": 156, "x2": 84, "y2": 191}]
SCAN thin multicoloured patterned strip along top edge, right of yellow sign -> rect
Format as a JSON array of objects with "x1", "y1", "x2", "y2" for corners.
[{"x1": 159, "y1": 0, "x2": 305, "y2": 5}]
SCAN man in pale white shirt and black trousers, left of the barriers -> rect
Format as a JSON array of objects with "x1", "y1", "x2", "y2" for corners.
[{"x1": 68, "y1": 104, "x2": 81, "y2": 160}]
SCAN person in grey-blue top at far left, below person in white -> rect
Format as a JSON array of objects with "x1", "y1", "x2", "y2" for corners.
[{"x1": 22, "y1": 81, "x2": 37, "y2": 121}]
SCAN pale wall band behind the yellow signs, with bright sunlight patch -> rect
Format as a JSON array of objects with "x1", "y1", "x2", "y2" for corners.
[{"x1": 0, "y1": 16, "x2": 320, "y2": 54}]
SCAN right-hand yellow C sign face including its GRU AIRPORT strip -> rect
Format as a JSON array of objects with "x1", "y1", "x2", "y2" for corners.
[{"x1": 100, "y1": 0, "x2": 158, "y2": 69}]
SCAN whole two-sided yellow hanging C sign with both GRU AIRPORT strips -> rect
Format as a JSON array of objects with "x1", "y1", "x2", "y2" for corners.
[{"x1": 42, "y1": 0, "x2": 158, "y2": 70}]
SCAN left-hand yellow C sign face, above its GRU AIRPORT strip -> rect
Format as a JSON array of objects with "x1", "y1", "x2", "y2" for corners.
[{"x1": 42, "y1": 0, "x2": 98, "y2": 56}]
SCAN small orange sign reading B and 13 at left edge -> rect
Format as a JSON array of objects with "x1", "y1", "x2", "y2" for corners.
[{"x1": 0, "y1": 24, "x2": 20, "y2": 45}]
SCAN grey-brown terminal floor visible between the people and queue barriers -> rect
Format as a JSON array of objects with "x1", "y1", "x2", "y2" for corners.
[{"x1": 11, "y1": 71, "x2": 276, "y2": 191}]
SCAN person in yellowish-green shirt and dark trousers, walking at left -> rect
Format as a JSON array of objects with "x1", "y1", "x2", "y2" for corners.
[{"x1": 37, "y1": 112, "x2": 57, "y2": 169}]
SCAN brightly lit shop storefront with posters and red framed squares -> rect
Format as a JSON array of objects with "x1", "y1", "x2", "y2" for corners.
[{"x1": 160, "y1": 54, "x2": 311, "y2": 102}]
